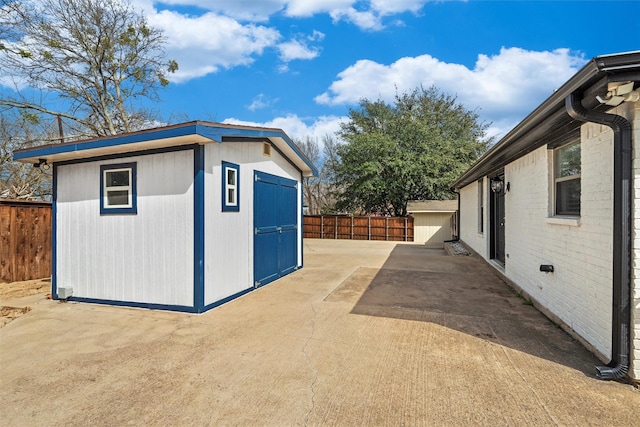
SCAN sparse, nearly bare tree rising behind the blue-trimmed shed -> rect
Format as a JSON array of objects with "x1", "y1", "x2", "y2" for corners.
[{"x1": 0, "y1": 0, "x2": 178, "y2": 136}]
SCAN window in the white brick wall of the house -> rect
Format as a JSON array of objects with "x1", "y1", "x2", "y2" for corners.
[{"x1": 553, "y1": 141, "x2": 581, "y2": 216}]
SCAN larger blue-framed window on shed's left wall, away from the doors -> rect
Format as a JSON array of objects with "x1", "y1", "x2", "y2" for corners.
[{"x1": 100, "y1": 163, "x2": 138, "y2": 215}]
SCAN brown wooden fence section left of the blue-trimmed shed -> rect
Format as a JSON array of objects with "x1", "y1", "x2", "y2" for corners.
[{"x1": 0, "y1": 199, "x2": 51, "y2": 282}]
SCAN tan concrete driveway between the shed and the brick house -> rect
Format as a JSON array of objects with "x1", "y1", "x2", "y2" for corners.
[{"x1": 0, "y1": 240, "x2": 640, "y2": 426}]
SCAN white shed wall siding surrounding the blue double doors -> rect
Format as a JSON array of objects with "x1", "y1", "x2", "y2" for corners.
[{"x1": 204, "y1": 142, "x2": 302, "y2": 304}]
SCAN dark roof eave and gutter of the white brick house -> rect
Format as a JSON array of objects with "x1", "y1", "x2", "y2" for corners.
[{"x1": 451, "y1": 51, "x2": 640, "y2": 189}]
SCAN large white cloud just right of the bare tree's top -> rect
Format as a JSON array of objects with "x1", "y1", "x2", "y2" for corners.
[{"x1": 130, "y1": 0, "x2": 332, "y2": 83}]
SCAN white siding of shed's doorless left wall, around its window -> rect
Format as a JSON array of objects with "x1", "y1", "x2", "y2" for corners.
[{"x1": 56, "y1": 150, "x2": 194, "y2": 306}]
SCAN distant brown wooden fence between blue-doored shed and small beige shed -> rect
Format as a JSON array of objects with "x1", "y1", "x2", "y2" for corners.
[{"x1": 304, "y1": 215, "x2": 413, "y2": 242}]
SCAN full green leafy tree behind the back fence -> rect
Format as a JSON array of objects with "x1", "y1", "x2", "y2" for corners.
[{"x1": 332, "y1": 87, "x2": 491, "y2": 216}]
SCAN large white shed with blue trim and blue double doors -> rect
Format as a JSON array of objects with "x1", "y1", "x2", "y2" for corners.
[{"x1": 14, "y1": 121, "x2": 317, "y2": 313}]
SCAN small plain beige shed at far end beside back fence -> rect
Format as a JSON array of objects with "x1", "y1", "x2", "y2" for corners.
[{"x1": 407, "y1": 200, "x2": 458, "y2": 247}]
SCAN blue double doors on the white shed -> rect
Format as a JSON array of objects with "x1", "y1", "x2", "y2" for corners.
[{"x1": 253, "y1": 171, "x2": 298, "y2": 287}]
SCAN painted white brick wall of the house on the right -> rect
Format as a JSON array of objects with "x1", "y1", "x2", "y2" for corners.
[{"x1": 460, "y1": 103, "x2": 640, "y2": 379}]
